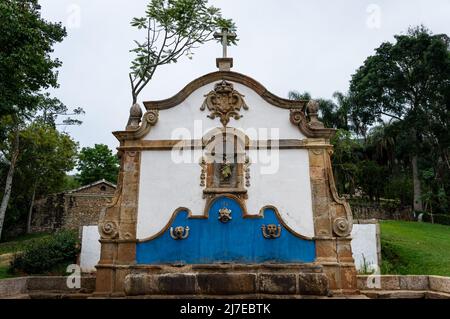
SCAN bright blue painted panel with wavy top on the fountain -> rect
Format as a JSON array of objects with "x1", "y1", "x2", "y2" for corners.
[{"x1": 136, "y1": 197, "x2": 316, "y2": 264}]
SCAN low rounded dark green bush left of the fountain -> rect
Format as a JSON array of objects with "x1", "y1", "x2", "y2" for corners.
[{"x1": 10, "y1": 231, "x2": 79, "y2": 275}]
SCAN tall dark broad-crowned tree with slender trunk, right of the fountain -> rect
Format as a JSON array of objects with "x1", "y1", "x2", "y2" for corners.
[{"x1": 350, "y1": 26, "x2": 450, "y2": 211}]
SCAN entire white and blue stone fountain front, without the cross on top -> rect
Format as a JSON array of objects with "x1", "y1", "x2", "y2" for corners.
[{"x1": 96, "y1": 71, "x2": 356, "y2": 296}]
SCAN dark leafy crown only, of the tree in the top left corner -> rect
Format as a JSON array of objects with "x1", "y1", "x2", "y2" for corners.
[{"x1": 0, "y1": 0, "x2": 66, "y2": 117}]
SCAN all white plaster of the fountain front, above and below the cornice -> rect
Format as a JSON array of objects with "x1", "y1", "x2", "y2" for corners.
[{"x1": 137, "y1": 83, "x2": 314, "y2": 239}]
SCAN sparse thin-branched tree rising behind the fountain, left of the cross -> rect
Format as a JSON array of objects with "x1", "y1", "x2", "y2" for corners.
[{"x1": 129, "y1": 0, "x2": 236, "y2": 104}]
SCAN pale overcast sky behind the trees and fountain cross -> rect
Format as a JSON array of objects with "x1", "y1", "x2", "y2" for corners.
[{"x1": 40, "y1": 0, "x2": 450, "y2": 148}]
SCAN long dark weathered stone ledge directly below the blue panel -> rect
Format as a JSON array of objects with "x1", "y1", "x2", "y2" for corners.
[{"x1": 124, "y1": 272, "x2": 330, "y2": 296}]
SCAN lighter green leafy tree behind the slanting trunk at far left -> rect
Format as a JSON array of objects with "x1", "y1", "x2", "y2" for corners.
[{"x1": 0, "y1": 122, "x2": 78, "y2": 240}]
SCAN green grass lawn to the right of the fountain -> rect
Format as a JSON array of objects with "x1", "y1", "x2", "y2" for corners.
[{"x1": 380, "y1": 221, "x2": 450, "y2": 276}]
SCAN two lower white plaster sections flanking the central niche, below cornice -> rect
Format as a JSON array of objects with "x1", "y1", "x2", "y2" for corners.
[{"x1": 137, "y1": 150, "x2": 314, "y2": 239}]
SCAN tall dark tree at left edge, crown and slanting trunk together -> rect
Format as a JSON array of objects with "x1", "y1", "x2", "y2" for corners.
[{"x1": 0, "y1": 0, "x2": 83, "y2": 240}]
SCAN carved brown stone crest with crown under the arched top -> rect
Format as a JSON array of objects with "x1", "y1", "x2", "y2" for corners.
[{"x1": 200, "y1": 80, "x2": 248, "y2": 127}]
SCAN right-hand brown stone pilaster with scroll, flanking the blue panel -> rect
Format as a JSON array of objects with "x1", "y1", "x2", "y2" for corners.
[{"x1": 307, "y1": 139, "x2": 356, "y2": 293}]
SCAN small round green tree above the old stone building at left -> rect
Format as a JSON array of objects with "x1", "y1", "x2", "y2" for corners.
[{"x1": 77, "y1": 144, "x2": 119, "y2": 185}]
